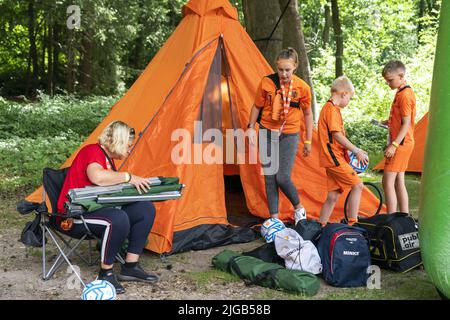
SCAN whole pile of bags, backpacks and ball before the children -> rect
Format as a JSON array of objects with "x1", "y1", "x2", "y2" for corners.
[{"x1": 213, "y1": 213, "x2": 422, "y2": 295}]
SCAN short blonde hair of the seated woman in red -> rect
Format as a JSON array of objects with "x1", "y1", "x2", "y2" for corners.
[{"x1": 98, "y1": 121, "x2": 135, "y2": 157}]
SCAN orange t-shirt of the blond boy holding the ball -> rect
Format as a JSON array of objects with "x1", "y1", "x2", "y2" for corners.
[{"x1": 318, "y1": 101, "x2": 347, "y2": 168}]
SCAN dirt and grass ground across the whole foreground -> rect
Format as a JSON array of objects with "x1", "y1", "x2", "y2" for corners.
[{"x1": 0, "y1": 181, "x2": 439, "y2": 300}]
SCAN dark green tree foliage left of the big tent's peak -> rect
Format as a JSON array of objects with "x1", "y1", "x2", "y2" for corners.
[{"x1": 0, "y1": 0, "x2": 186, "y2": 96}]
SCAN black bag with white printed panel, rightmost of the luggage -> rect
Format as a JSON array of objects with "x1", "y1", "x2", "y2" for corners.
[{"x1": 354, "y1": 212, "x2": 422, "y2": 272}]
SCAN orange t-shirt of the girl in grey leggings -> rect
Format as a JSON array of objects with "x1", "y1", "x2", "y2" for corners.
[{"x1": 255, "y1": 75, "x2": 311, "y2": 134}]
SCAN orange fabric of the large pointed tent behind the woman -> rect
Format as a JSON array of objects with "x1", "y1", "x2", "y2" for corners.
[{"x1": 27, "y1": 0, "x2": 384, "y2": 253}]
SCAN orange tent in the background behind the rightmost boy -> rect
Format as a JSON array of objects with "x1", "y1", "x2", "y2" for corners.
[{"x1": 374, "y1": 113, "x2": 428, "y2": 172}]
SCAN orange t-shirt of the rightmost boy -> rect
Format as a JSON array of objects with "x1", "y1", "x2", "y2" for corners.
[{"x1": 388, "y1": 86, "x2": 416, "y2": 144}]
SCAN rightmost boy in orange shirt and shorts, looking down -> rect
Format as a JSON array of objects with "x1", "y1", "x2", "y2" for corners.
[{"x1": 382, "y1": 60, "x2": 416, "y2": 213}]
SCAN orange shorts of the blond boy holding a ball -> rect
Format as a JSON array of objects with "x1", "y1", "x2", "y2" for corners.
[{"x1": 325, "y1": 163, "x2": 362, "y2": 193}]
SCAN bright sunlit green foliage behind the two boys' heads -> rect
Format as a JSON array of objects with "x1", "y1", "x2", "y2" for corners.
[{"x1": 300, "y1": 0, "x2": 440, "y2": 122}]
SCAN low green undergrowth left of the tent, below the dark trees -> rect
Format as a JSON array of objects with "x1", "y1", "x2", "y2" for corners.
[{"x1": 0, "y1": 95, "x2": 117, "y2": 189}]
